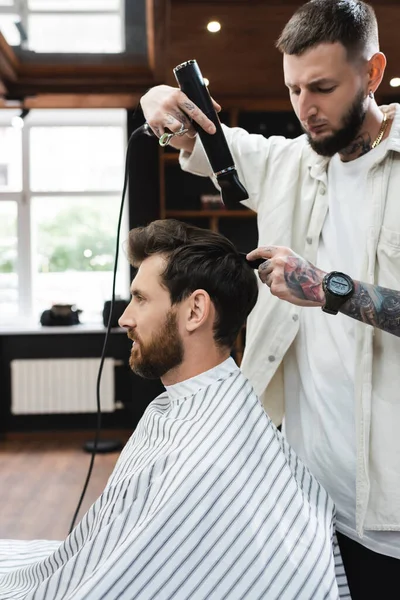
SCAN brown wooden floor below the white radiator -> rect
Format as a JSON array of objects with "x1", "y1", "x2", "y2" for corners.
[{"x1": 0, "y1": 431, "x2": 130, "y2": 540}]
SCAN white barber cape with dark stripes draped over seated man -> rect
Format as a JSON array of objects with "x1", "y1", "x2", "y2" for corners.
[{"x1": 0, "y1": 359, "x2": 349, "y2": 600}]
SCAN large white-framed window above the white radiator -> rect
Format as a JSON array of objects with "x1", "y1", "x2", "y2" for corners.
[{"x1": 0, "y1": 110, "x2": 129, "y2": 323}]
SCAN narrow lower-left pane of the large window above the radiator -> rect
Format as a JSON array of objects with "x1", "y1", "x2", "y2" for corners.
[{"x1": 0, "y1": 200, "x2": 18, "y2": 322}]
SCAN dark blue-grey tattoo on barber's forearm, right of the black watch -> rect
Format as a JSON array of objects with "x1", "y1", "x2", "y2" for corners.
[{"x1": 340, "y1": 281, "x2": 400, "y2": 336}]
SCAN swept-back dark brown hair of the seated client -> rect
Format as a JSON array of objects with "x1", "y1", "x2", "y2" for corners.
[{"x1": 129, "y1": 219, "x2": 258, "y2": 348}]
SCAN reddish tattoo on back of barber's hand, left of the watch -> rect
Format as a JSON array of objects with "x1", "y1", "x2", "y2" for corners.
[{"x1": 284, "y1": 256, "x2": 325, "y2": 305}]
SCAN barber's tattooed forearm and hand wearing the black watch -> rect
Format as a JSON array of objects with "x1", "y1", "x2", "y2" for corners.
[{"x1": 247, "y1": 246, "x2": 400, "y2": 337}]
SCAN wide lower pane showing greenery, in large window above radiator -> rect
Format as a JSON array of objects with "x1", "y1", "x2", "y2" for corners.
[{"x1": 32, "y1": 196, "x2": 129, "y2": 323}]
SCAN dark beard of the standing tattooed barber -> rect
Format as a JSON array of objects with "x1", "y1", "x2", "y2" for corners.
[{"x1": 306, "y1": 90, "x2": 366, "y2": 157}]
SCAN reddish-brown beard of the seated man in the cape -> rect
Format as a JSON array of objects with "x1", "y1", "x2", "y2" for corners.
[{"x1": 129, "y1": 310, "x2": 184, "y2": 379}]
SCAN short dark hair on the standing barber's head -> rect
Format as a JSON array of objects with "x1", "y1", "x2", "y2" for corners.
[{"x1": 276, "y1": 0, "x2": 379, "y2": 61}]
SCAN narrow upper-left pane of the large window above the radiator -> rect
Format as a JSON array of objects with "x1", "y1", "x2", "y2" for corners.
[{"x1": 0, "y1": 126, "x2": 22, "y2": 192}]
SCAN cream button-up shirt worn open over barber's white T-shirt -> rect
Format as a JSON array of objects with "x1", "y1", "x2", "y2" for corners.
[{"x1": 180, "y1": 105, "x2": 400, "y2": 535}]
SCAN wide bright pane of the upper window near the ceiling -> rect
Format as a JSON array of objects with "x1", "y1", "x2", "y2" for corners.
[{"x1": 28, "y1": 13, "x2": 123, "y2": 54}]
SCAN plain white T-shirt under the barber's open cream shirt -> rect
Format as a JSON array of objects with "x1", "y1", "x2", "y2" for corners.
[{"x1": 284, "y1": 141, "x2": 400, "y2": 558}]
